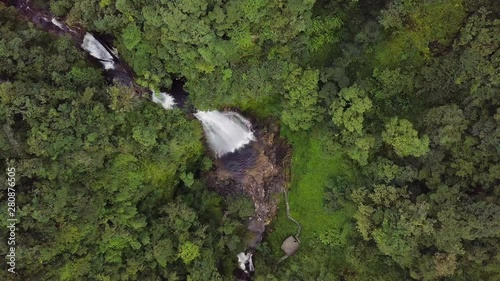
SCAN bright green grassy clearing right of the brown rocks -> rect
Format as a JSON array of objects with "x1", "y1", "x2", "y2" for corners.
[{"x1": 268, "y1": 126, "x2": 354, "y2": 259}]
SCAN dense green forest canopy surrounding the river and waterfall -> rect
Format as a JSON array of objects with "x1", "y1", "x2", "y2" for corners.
[{"x1": 0, "y1": 0, "x2": 500, "y2": 281}]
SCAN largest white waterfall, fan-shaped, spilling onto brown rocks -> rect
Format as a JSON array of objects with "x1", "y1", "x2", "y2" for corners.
[{"x1": 194, "y1": 111, "x2": 255, "y2": 157}]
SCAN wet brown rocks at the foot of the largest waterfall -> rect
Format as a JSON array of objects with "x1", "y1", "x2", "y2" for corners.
[{"x1": 207, "y1": 121, "x2": 291, "y2": 224}]
